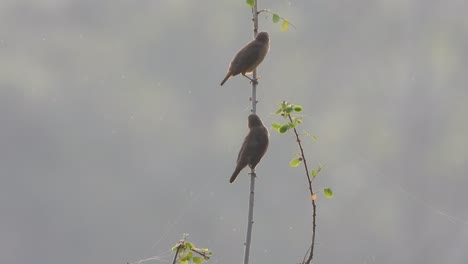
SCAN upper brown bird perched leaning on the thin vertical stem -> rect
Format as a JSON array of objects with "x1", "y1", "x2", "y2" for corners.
[{"x1": 221, "y1": 32, "x2": 270, "y2": 85}]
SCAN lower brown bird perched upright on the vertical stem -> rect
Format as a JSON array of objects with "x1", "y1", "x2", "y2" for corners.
[{"x1": 229, "y1": 114, "x2": 269, "y2": 183}]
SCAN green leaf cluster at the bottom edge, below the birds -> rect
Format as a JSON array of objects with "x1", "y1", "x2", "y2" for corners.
[{"x1": 172, "y1": 240, "x2": 213, "y2": 264}]
